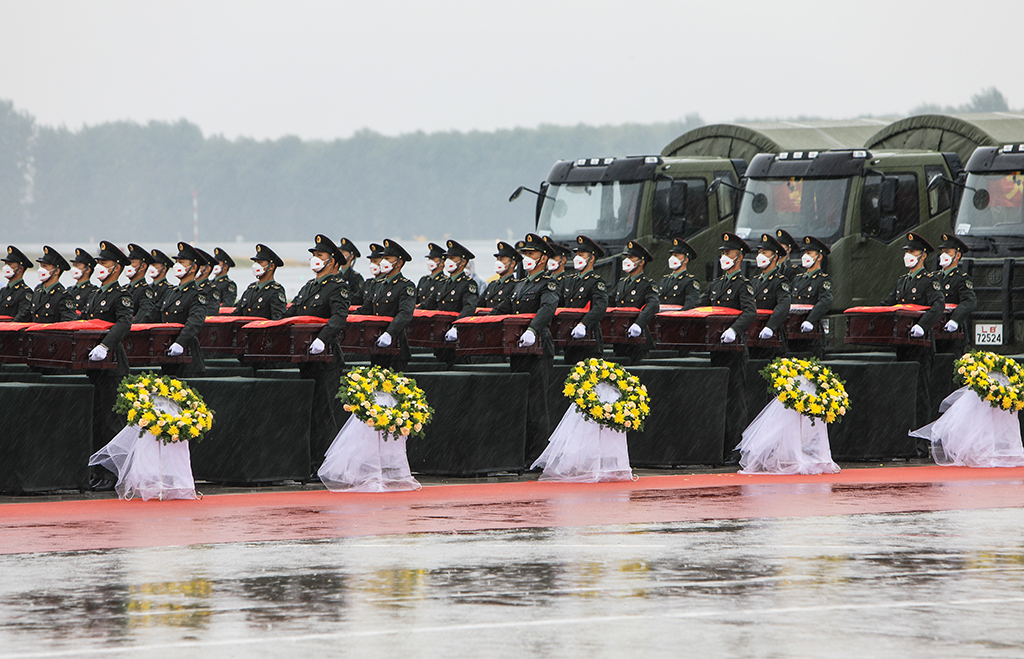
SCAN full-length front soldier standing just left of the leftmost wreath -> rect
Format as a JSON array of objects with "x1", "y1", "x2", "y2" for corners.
[{"x1": 80, "y1": 240, "x2": 134, "y2": 491}]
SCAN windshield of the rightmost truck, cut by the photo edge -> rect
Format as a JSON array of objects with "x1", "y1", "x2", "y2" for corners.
[{"x1": 956, "y1": 172, "x2": 1024, "y2": 235}]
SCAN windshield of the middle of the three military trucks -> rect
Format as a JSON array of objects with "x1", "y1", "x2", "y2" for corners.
[{"x1": 736, "y1": 178, "x2": 850, "y2": 245}]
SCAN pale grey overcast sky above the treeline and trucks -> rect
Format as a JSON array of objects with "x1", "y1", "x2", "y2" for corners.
[{"x1": 0, "y1": 0, "x2": 1024, "y2": 139}]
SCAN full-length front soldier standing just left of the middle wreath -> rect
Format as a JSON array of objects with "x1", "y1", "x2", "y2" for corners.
[{"x1": 490, "y1": 233, "x2": 558, "y2": 467}]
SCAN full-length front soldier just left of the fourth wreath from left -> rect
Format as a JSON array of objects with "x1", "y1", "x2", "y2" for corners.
[{"x1": 699, "y1": 231, "x2": 758, "y2": 464}]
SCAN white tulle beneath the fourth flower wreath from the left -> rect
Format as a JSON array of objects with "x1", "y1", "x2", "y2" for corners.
[{"x1": 736, "y1": 378, "x2": 840, "y2": 474}]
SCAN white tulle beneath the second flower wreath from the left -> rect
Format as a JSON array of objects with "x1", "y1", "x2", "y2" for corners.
[{"x1": 316, "y1": 393, "x2": 421, "y2": 492}]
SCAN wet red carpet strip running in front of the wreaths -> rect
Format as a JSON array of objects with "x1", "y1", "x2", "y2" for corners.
[{"x1": 0, "y1": 466, "x2": 1024, "y2": 554}]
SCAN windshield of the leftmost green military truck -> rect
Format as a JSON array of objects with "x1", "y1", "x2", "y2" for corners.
[{"x1": 537, "y1": 181, "x2": 643, "y2": 241}]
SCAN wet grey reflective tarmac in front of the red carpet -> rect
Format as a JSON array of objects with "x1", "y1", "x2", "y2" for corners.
[{"x1": 0, "y1": 507, "x2": 1024, "y2": 658}]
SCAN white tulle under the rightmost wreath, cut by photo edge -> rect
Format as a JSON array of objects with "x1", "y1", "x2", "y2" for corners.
[{"x1": 910, "y1": 374, "x2": 1024, "y2": 467}]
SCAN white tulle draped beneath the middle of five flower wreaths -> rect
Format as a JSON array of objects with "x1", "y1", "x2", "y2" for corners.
[{"x1": 532, "y1": 383, "x2": 633, "y2": 483}]
